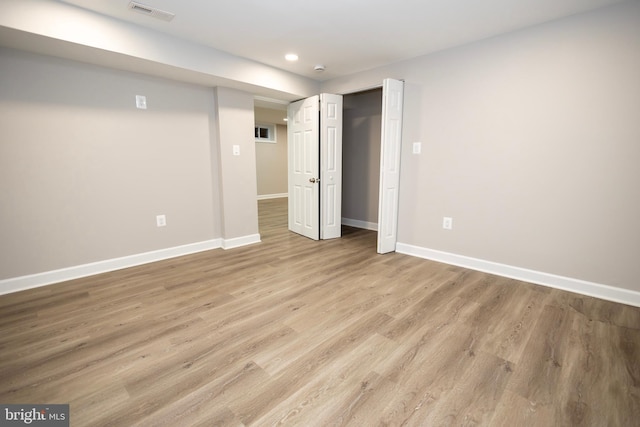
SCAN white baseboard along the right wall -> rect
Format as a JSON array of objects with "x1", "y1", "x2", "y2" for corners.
[{"x1": 396, "y1": 243, "x2": 640, "y2": 307}]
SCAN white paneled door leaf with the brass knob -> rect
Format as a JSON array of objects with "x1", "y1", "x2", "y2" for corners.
[{"x1": 287, "y1": 96, "x2": 320, "y2": 240}]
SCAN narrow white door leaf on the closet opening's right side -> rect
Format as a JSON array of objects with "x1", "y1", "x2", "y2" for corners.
[{"x1": 378, "y1": 79, "x2": 404, "y2": 254}]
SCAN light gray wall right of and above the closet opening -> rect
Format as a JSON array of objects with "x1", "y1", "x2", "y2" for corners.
[{"x1": 322, "y1": 2, "x2": 640, "y2": 291}]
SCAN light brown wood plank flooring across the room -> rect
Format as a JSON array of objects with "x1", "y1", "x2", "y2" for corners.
[{"x1": 0, "y1": 199, "x2": 640, "y2": 426}]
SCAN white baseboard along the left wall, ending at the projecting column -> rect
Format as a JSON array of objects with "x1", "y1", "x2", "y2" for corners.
[{"x1": 0, "y1": 239, "x2": 222, "y2": 295}]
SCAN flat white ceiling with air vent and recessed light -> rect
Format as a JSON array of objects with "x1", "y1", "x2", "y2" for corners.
[{"x1": 59, "y1": 0, "x2": 622, "y2": 81}]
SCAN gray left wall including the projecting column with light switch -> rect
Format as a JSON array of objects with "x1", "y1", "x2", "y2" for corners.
[{"x1": 0, "y1": 49, "x2": 258, "y2": 279}]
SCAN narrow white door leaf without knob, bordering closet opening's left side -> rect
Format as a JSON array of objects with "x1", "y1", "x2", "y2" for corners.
[{"x1": 320, "y1": 93, "x2": 342, "y2": 239}]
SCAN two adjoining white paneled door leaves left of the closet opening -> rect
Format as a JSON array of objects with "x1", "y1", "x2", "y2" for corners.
[{"x1": 287, "y1": 93, "x2": 342, "y2": 240}]
